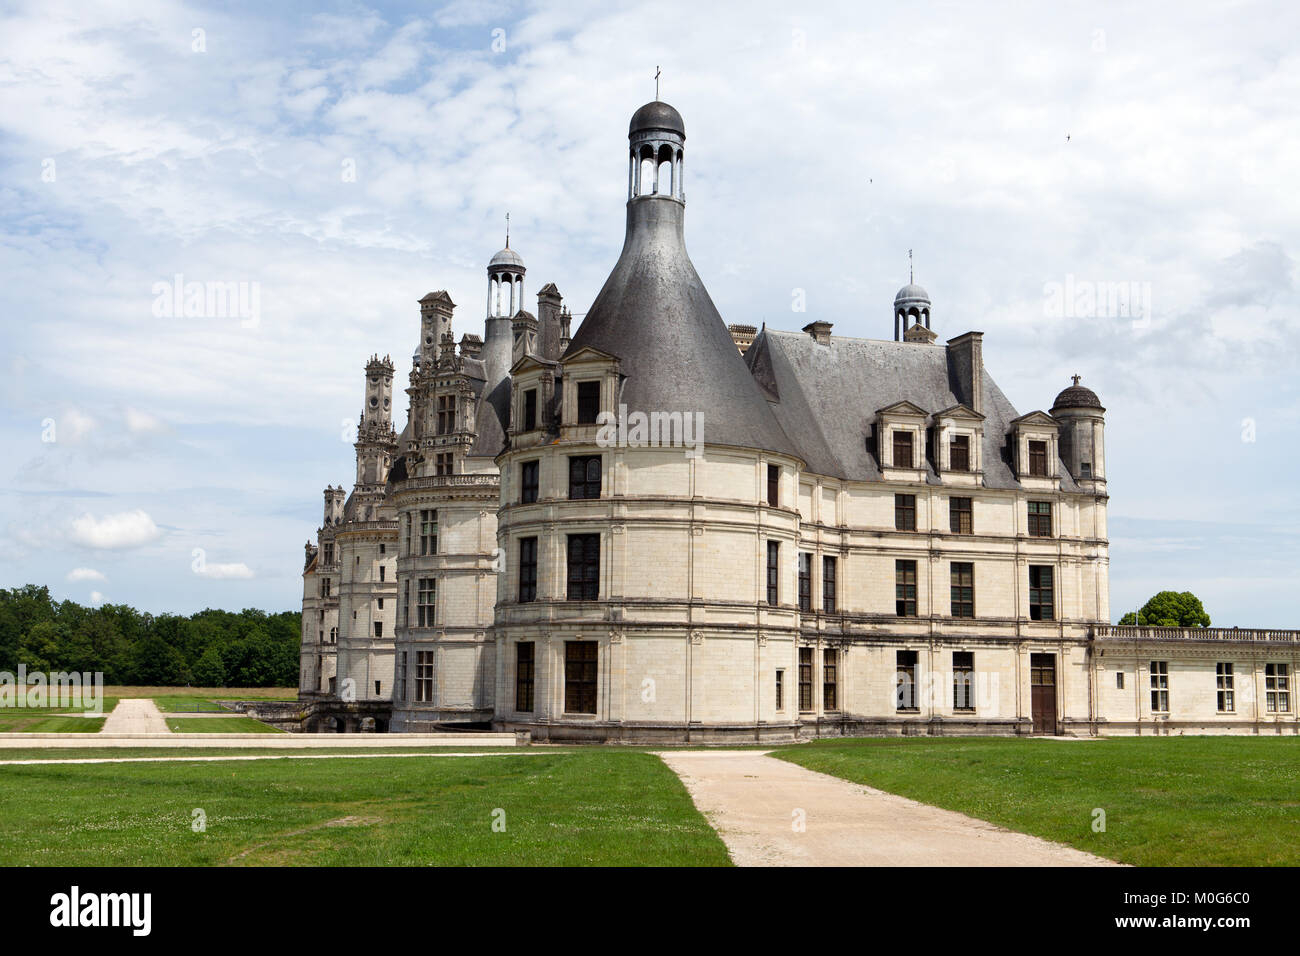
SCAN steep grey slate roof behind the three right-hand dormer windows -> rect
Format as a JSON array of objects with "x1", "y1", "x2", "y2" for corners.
[{"x1": 745, "y1": 329, "x2": 1078, "y2": 492}]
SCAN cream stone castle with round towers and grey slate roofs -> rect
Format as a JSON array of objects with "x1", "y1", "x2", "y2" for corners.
[{"x1": 300, "y1": 101, "x2": 1300, "y2": 741}]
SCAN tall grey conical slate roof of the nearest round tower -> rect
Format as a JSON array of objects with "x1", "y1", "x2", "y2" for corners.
[{"x1": 566, "y1": 195, "x2": 797, "y2": 457}]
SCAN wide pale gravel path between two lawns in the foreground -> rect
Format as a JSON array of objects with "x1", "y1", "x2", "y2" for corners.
[{"x1": 659, "y1": 750, "x2": 1117, "y2": 866}]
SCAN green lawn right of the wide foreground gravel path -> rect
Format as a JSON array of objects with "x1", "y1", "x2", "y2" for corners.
[{"x1": 775, "y1": 737, "x2": 1300, "y2": 866}]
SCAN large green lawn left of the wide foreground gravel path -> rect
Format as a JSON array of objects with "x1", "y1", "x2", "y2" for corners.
[{"x1": 0, "y1": 749, "x2": 728, "y2": 866}]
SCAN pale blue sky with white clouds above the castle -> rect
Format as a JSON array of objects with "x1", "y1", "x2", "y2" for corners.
[{"x1": 0, "y1": 0, "x2": 1300, "y2": 627}]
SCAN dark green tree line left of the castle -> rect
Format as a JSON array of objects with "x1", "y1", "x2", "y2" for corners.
[{"x1": 0, "y1": 584, "x2": 302, "y2": 687}]
